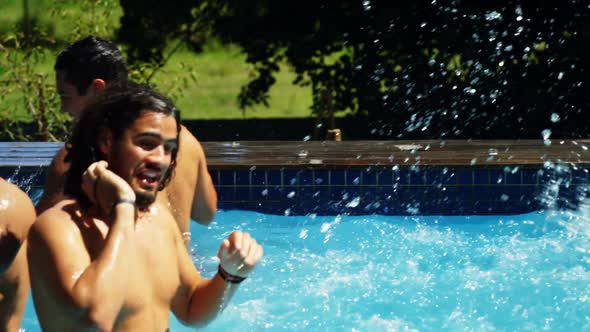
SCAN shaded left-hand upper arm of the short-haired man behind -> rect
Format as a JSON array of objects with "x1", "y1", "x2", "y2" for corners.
[{"x1": 36, "y1": 146, "x2": 68, "y2": 215}]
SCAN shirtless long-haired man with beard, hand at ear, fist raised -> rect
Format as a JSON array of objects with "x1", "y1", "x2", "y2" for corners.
[{"x1": 28, "y1": 85, "x2": 263, "y2": 331}]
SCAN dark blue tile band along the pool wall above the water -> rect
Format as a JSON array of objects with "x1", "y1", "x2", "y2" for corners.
[{"x1": 0, "y1": 165, "x2": 590, "y2": 215}]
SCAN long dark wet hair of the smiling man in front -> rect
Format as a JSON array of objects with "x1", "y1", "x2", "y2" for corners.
[{"x1": 64, "y1": 83, "x2": 180, "y2": 206}]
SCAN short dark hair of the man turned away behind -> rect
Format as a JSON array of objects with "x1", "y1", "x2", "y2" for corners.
[{"x1": 54, "y1": 36, "x2": 127, "y2": 95}]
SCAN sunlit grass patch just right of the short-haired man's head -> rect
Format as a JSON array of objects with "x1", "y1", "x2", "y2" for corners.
[{"x1": 148, "y1": 46, "x2": 312, "y2": 119}]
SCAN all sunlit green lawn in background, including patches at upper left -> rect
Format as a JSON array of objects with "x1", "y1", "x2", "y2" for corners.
[{"x1": 0, "y1": 0, "x2": 312, "y2": 119}]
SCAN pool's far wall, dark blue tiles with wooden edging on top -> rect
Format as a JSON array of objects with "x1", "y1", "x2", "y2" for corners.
[{"x1": 0, "y1": 142, "x2": 590, "y2": 215}]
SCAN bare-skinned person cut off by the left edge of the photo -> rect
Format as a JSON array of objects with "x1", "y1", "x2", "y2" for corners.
[{"x1": 0, "y1": 178, "x2": 36, "y2": 331}]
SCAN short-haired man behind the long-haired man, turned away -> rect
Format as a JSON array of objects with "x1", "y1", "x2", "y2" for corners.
[{"x1": 37, "y1": 36, "x2": 217, "y2": 243}]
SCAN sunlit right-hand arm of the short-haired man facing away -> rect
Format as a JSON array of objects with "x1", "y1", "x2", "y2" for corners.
[{"x1": 180, "y1": 127, "x2": 217, "y2": 225}]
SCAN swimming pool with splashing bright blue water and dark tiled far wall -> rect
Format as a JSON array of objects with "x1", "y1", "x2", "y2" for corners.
[{"x1": 4, "y1": 143, "x2": 590, "y2": 331}]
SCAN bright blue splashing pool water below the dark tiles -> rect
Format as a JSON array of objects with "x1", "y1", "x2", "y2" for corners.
[{"x1": 18, "y1": 207, "x2": 590, "y2": 332}]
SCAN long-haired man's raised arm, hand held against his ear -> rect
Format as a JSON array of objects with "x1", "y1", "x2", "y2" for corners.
[{"x1": 28, "y1": 162, "x2": 136, "y2": 330}]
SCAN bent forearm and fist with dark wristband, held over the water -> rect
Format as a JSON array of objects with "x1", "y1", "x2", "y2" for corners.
[{"x1": 172, "y1": 231, "x2": 263, "y2": 326}]
